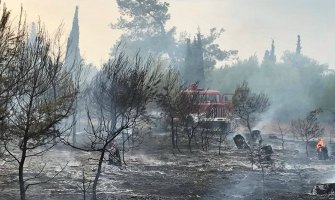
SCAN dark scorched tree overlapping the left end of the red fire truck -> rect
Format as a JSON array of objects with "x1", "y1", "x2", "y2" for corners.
[{"x1": 158, "y1": 69, "x2": 206, "y2": 151}]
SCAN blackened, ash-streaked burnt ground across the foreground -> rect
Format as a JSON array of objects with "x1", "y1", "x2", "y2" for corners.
[{"x1": 0, "y1": 130, "x2": 335, "y2": 200}]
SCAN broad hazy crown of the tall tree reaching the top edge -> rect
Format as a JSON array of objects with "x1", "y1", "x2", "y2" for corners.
[{"x1": 111, "y1": 0, "x2": 177, "y2": 57}]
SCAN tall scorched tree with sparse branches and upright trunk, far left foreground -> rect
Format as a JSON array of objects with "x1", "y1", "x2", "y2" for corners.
[{"x1": 3, "y1": 22, "x2": 77, "y2": 200}]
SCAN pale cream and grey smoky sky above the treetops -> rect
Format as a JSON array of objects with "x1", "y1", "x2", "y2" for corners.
[{"x1": 5, "y1": 0, "x2": 335, "y2": 68}]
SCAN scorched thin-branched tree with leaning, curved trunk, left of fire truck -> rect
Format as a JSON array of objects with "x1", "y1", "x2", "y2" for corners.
[{"x1": 66, "y1": 52, "x2": 161, "y2": 200}]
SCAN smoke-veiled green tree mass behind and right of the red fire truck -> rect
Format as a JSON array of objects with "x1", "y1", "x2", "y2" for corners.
[{"x1": 208, "y1": 45, "x2": 335, "y2": 121}]
